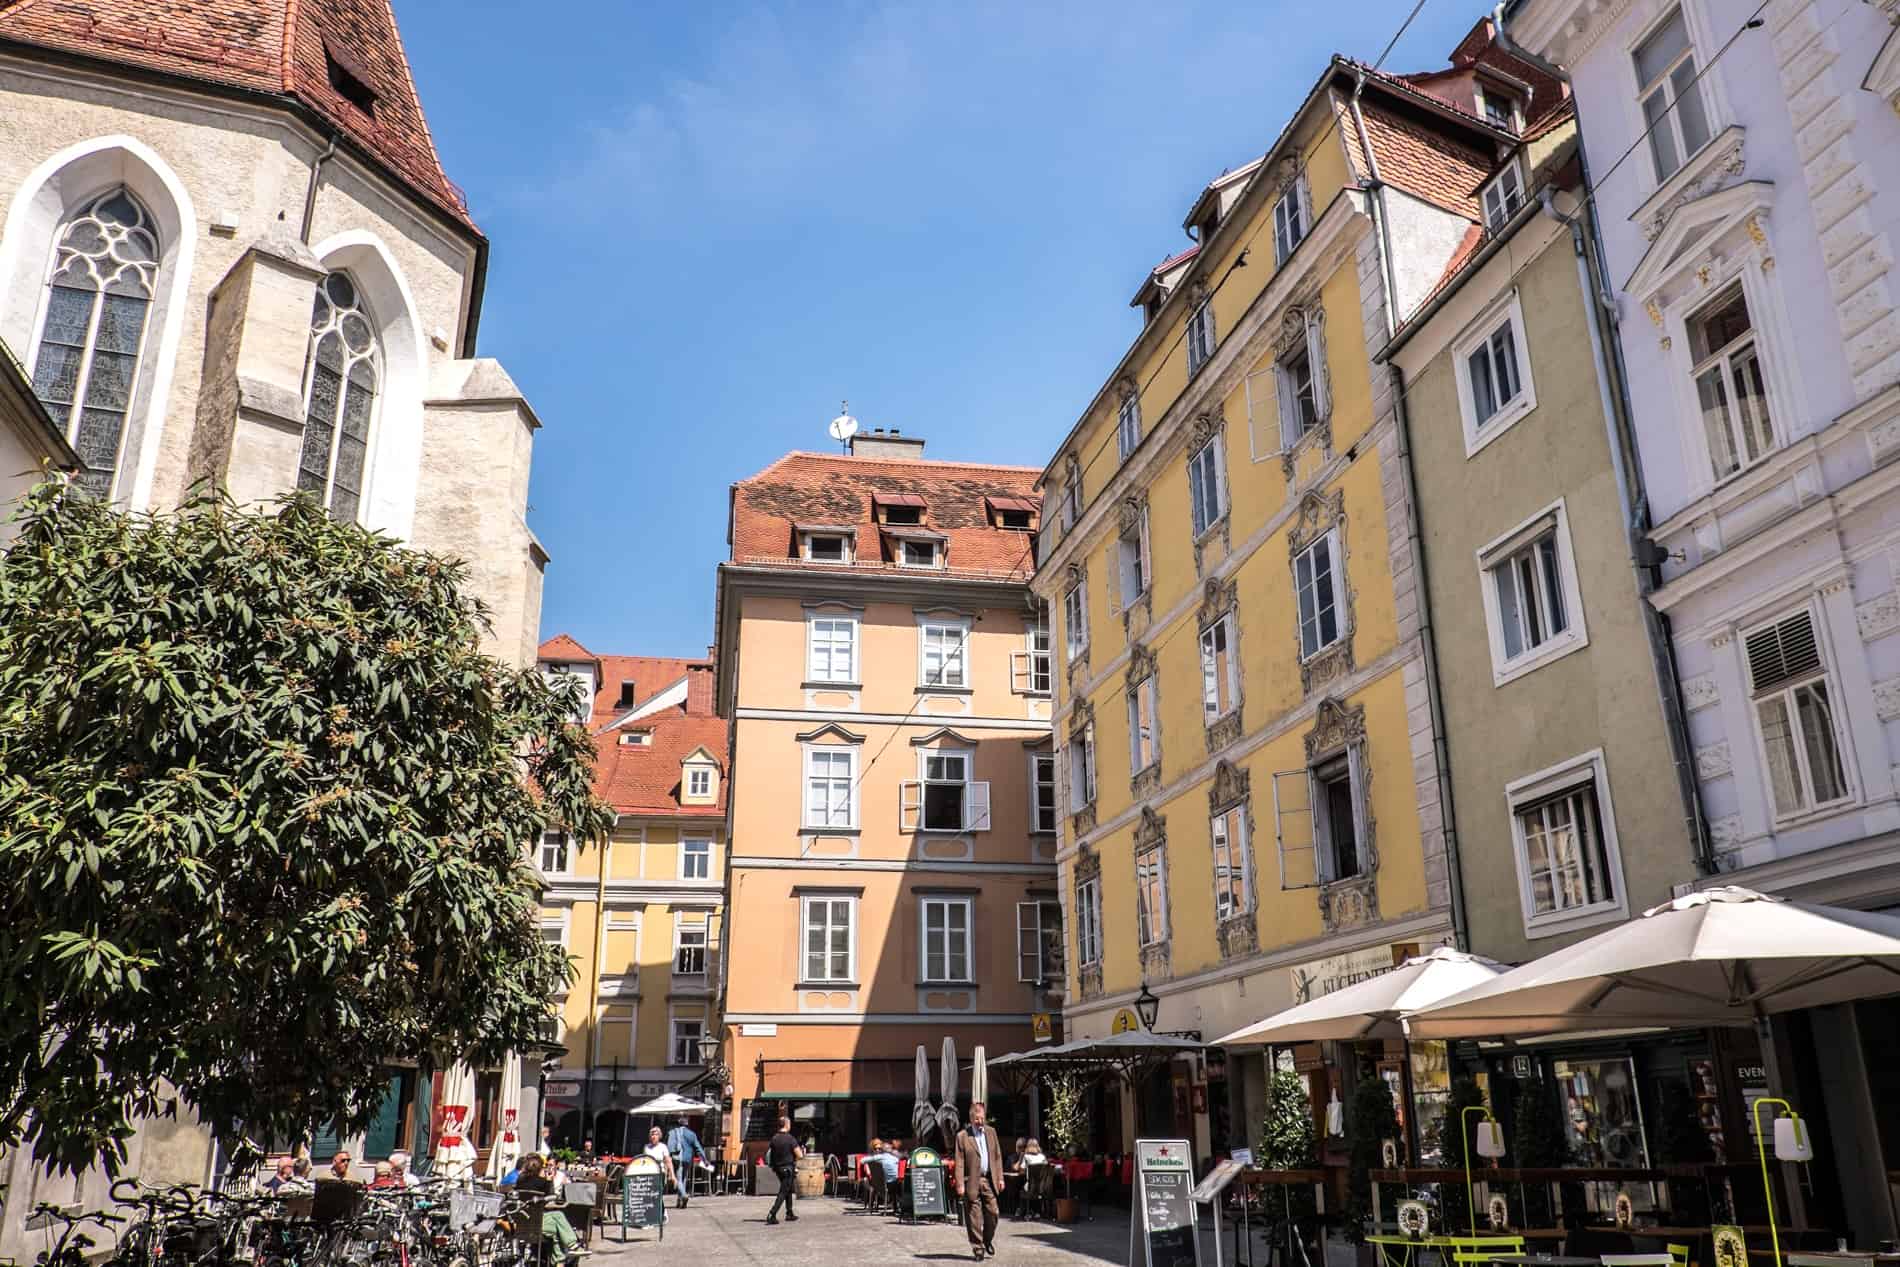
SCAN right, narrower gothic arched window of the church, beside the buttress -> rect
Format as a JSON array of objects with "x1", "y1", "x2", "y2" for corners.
[{"x1": 296, "y1": 272, "x2": 380, "y2": 522}]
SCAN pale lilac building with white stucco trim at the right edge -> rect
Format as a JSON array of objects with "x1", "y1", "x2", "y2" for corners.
[{"x1": 1509, "y1": 0, "x2": 1900, "y2": 906}]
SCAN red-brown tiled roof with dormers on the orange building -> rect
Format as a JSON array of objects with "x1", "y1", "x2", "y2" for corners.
[{"x1": 732, "y1": 452, "x2": 1039, "y2": 579}]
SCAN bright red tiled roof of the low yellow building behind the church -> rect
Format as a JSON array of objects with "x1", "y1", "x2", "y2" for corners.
[{"x1": 540, "y1": 634, "x2": 732, "y2": 819}]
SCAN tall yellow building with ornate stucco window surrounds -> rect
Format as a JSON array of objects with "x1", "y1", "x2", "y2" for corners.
[{"x1": 1034, "y1": 59, "x2": 1520, "y2": 1151}]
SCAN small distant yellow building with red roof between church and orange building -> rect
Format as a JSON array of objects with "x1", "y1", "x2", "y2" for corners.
[{"x1": 536, "y1": 634, "x2": 728, "y2": 1153}]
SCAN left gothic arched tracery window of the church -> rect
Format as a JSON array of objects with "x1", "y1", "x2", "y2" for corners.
[{"x1": 32, "y1": 186, "x2": 158, "y2": 498}]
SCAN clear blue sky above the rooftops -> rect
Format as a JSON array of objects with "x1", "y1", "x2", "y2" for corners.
[{"x1": 397, "y1": 0, "x2": 1486, "y2": 655}]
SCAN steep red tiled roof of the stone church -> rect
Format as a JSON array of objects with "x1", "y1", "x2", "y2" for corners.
[{"x1": 0, "y1": 0, "x2": 479, "y2": 234}]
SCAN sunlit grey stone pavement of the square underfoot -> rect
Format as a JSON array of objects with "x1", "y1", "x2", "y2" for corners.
[{"x1": 583, "y1": 1197, "x2": 1264, "y2": 1267}]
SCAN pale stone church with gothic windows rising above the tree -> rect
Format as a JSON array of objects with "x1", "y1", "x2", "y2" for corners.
[{"x1": 0, "y1": 0, "x2": 545, "y2": 665}]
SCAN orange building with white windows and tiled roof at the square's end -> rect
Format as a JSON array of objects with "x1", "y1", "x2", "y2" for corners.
[{"x1": 716, "y1": 433, "x2": 1062, "y2": 1155}]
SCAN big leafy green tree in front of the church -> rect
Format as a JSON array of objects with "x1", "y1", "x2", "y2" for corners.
[{"x1": 0, "y1": 484, "x2": 612, "y2": 1170}]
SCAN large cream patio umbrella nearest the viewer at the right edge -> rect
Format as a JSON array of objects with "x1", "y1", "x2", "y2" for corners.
[{"x1": 1404, "y1": 885, "x2": 1900, "y2": 1039}]
